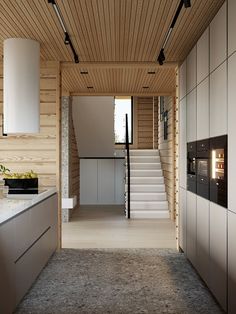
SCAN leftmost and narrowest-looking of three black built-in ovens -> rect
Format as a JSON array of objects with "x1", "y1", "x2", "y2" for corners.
[{"x1": 187, "y1": 142, "x2": 197, "y2": 193}]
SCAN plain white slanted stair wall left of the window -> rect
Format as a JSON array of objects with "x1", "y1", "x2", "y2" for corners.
[{"x1": 72, "y1": 96, "x2": 114, "y2": 157}]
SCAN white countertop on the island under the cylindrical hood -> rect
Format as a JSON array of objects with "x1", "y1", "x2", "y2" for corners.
[{"x1": 0, "y1": 188, "x2": 57, "y2": 225}]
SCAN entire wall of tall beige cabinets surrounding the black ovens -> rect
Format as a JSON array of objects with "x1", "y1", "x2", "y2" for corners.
[{"x1": 179, "y1": 0, "x2": 236, "y2": 313}]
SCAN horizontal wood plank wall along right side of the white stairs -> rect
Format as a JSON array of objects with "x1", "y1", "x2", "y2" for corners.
[{"x1": 158, "y1": 96, "x2": 175, "y2": 219}]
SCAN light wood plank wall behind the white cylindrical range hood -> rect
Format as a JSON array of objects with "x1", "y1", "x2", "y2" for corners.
[{"x1": 0, "y1": 62, "x2": 60, "y2": 187}]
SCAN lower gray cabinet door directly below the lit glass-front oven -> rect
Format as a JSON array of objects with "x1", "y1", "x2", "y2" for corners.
[{"x1": 209, "y1": 202, "x2": 227, "y2": 310}]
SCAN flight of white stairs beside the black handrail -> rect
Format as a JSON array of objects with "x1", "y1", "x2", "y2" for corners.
[{"x1": 125, "y1": 149, "x2": 169, "y2": 219}]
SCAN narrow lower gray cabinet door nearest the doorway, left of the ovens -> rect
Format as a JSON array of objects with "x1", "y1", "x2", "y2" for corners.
[{"x1": 179, "y1": 187, "x2": 186, "y2": 252}]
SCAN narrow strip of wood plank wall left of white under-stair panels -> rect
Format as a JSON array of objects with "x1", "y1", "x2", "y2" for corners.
[{"x1": 69, "y1": 103, "x2": 80, "y2": 207}]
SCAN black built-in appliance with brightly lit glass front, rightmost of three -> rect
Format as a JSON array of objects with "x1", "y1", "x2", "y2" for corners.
[{"x1": 210, "y1": 135, "x2": 228, "y2": 208}]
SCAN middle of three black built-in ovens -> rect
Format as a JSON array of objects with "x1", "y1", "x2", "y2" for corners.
[{"x1": 196, "y1": 139, "x2": 210, "y2": 199}]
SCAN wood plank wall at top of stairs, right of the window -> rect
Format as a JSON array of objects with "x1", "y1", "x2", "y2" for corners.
[{"x1": 136, "y1": 97, "x2": 153, "y2": 149}]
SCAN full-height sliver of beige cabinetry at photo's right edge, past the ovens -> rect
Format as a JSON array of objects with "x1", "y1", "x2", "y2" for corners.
[{"x1": 228, "y1": 0, "x2": 236, "y2": 314}]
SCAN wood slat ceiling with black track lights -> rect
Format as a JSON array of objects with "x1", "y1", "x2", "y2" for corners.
[{"x1": 0, "y1": 0, "x2": 224, "y2": 94}]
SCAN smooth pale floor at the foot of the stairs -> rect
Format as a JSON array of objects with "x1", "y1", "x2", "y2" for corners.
[{"x1": 62, "y1": 205, "x2": 177, "y2": 248}]
